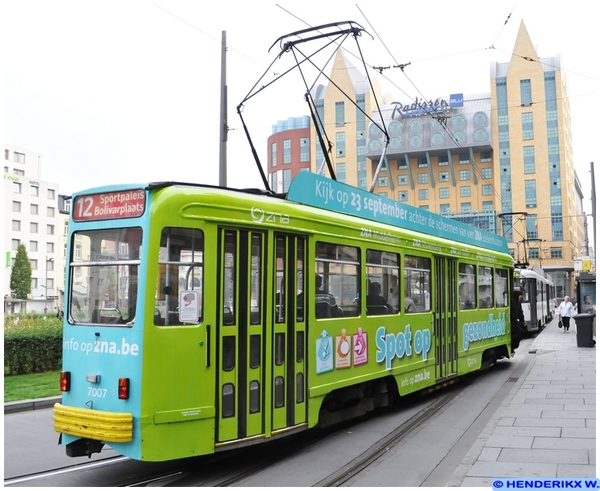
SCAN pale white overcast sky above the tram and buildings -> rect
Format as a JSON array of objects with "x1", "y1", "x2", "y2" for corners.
[{"x1": 0, "y1": 0, "x2": 600, "y2": 217}]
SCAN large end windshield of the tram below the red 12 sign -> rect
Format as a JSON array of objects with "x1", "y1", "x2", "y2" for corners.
[{"x1": 68, "y1": 227, "x2": 142, "y2": 326}]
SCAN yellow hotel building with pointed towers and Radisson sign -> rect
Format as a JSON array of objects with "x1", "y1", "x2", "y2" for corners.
[{"x1": 271, "y1": 23, "x2": 587, "y2": 296}]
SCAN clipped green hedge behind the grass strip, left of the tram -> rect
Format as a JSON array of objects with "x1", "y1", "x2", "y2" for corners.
[{"x1": 4, "y1": 314, "x2": 62, "y2": 375}]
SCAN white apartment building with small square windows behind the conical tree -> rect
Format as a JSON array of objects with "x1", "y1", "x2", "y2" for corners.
[{"x1": 4, "y1": 144, "x2": 66, "y2": 314}]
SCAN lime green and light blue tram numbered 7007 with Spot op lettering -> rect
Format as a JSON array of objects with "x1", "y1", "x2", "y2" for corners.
[{"x1": 54, "y1": 172, "x2": 513, "y2": 461}]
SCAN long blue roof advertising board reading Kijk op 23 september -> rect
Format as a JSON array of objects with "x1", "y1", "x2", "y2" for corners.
[{"x1": 287, "y1": 172, "x2": 508, "y2": 253}]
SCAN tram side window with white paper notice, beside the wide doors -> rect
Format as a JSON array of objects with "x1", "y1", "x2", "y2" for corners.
[{"x1": 154, "y1": 227, "x2": 204, "y2": 326}]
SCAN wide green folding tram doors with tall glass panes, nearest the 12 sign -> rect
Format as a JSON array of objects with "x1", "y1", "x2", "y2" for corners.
[{"x1": 215, "y1": 229, "x2": 306, "y2": 444}]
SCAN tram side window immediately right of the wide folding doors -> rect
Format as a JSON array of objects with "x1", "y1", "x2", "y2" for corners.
[{"x1": 315, "y1": 242, "x2": 360, "y2": 318}]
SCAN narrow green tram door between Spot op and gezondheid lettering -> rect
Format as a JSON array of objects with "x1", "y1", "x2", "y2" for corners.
[{"x1": 433, "y1": 257, "x2": 459, "y2": 380}]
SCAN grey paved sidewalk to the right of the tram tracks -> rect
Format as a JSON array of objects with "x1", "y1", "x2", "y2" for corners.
[{"x1": 446, "y1": 316, "x2": 596, "y2": 489}]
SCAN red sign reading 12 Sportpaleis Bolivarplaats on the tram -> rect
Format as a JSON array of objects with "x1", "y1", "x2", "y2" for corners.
[{"x1": 73, "y1": 189, "x2": 146, "y2": 222}]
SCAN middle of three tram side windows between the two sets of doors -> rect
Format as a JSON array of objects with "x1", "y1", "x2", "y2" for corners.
[{"x1": 365, "y1": 250, "x2": 400, "y2": 315}]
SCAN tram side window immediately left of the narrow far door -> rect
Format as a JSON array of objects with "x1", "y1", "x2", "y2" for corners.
[{"x1": 403, "y1": 256, "x2": 431, "y2": 313}]
